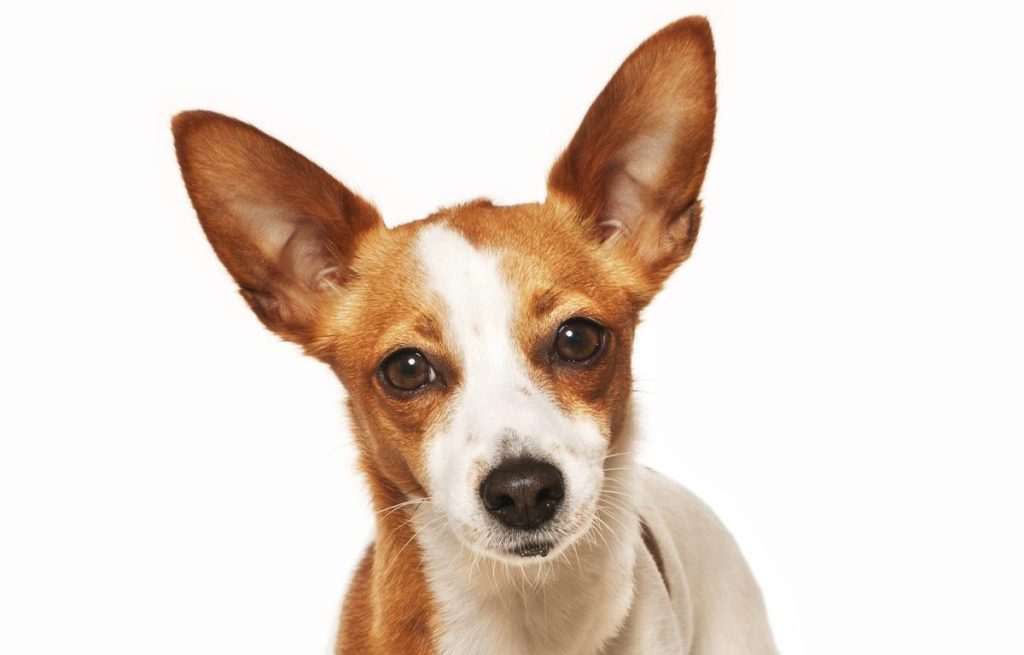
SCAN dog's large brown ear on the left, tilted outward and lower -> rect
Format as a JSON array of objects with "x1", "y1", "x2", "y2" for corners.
[{"x1": 171, "y1": 112, "x2": 383, "y2": 343}]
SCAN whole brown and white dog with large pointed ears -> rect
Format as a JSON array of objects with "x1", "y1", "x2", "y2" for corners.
[{"x1": 172, "y1": 17, "x2": 775, "y2": 655}]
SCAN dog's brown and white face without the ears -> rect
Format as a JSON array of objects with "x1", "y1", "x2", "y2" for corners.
[{"x1": 317, "y1": 202, "x2": 642, "y2": 556}]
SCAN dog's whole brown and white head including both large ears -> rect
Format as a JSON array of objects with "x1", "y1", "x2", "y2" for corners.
[{"x1": 174, "y1": 19, "x2": 715, "y2": 561}]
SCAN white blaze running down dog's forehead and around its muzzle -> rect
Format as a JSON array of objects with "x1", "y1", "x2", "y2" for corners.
[{"x1": 417, "y1": 225, "x2": 605, "y2": 529}]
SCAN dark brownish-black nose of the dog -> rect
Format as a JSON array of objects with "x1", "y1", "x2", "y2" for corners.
[{"x1": 480, "y1": 457, "x2": 565, "y2": 530}]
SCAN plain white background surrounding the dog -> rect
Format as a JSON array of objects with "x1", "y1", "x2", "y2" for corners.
[{"x1": 0, "y1": 1, "x2": 1024, "y2": 655}]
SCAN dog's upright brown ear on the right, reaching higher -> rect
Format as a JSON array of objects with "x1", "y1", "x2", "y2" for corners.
[{"x1": 548, "y1": 16, "x2": 715, "y2": 293}]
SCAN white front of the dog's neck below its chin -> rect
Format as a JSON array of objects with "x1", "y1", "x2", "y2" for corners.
[{"x1": 413, "y1": 453, "x2": 641, "y2": 655}]
